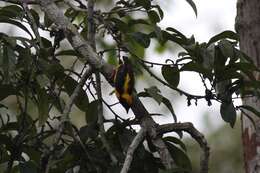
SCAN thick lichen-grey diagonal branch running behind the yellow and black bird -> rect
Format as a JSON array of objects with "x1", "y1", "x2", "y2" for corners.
[{"x1": 37, "y1": 0, "x2": 174, "y2": 169}]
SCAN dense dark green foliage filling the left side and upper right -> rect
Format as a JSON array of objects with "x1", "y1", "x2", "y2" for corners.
[{"x1": 0, "y1": 0, "x2": 260, "y2": 173}]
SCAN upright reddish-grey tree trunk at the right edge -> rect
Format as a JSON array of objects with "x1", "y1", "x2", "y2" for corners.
[{"x1": 236, "y1": 0, "x2": 260, "y2": 173}]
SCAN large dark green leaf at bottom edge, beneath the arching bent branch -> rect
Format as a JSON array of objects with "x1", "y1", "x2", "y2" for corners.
[{"x1": 166, "y1": 142, "x2": 192, "y2": 173}]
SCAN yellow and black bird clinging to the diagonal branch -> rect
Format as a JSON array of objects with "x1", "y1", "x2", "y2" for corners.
[{"x1": 114, "y1": 56, "x2": 134, "y2": 112}]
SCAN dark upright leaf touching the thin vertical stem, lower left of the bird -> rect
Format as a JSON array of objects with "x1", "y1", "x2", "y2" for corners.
[{"x1": 85, "y1": 100, "x2": 99, "y2": 124}]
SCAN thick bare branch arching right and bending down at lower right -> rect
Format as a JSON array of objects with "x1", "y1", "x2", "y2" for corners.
[{"x1": 157, "y1": 123, "x2": 210, "y2": 173}]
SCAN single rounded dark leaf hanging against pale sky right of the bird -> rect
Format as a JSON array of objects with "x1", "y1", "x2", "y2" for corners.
[{"x1": 161, "y1": 65, "x2": 180, "y2": 88}]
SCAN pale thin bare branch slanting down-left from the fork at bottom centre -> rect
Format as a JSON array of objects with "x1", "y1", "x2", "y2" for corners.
[{"x1": 120, "y1": 128, "x2": 146, "y2": 173}]
